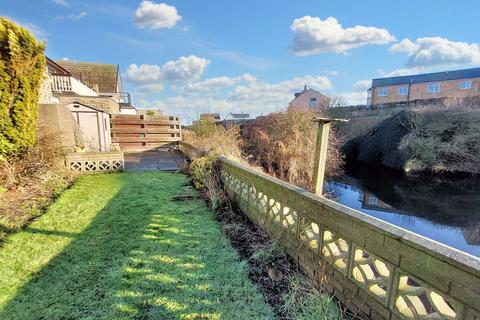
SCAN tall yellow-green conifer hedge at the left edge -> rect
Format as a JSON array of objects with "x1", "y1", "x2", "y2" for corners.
[{"x1": 0, "y1": 18, "x2": 45, "y2": 157}]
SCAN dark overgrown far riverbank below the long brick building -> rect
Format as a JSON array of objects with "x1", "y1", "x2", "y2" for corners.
[{"x1": 340, "y1": 106, "x2": 480, "y2": 174}]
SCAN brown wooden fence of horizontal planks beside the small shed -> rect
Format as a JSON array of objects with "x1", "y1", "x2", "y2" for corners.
[{"x1": 111, "y1": 115, "x2": 182, "y2": 150}]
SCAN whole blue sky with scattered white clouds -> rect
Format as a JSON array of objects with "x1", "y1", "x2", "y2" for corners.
[{"x1": 0, "y1": 0, "x2": 480, "y2": 123}]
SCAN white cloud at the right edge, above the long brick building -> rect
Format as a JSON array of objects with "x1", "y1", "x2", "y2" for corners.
[{"x1": 390, "y1": 37, "x2": 480, "y2": 68}]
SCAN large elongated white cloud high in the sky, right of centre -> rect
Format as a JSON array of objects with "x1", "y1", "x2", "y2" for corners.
[{"x1": 290, "y1": 16, "x2": 395, "y2": 56}]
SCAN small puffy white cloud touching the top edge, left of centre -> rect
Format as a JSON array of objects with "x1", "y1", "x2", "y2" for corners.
[{"x1": 134, "y1": 1, "x2": 182, "y2": 30}]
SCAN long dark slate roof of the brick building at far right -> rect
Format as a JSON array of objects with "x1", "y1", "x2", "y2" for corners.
[{"x1": 372, "y1": 68, "x2": 480, "y2": 87}]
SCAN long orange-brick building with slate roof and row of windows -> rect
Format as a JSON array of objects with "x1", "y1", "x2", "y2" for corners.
[{"x1": 367, "y1": 68, "x2": 480, "y2": 107}]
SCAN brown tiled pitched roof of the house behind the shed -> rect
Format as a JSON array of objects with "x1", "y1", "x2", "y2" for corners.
[{"x1": 55, "y1": 60, "x2": 119, "y2": 93}]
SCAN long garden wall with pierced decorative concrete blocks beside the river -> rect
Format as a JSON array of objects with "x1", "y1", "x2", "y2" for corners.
[{"x1": 180, "y1": 142, "x2": 480, "y2": 320}]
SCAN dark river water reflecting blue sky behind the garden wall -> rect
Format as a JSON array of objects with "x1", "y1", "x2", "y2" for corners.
[{"x1": 328, "y1": 166, "x2": 480, "y2": 257}]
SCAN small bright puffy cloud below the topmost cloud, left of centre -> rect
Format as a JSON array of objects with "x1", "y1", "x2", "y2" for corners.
[{"x1": 162, "y1": 55, "x2": 210, "y2": 81}]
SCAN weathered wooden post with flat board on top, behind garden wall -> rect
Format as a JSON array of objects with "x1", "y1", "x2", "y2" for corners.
[{"x1": 312, "y1": 118, "x2": 348, "y2": 196}]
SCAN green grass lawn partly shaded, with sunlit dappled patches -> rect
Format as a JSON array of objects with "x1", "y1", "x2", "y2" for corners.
[{"x1": 0, "y1": 172, "x2": 273, "y2": 320}]
